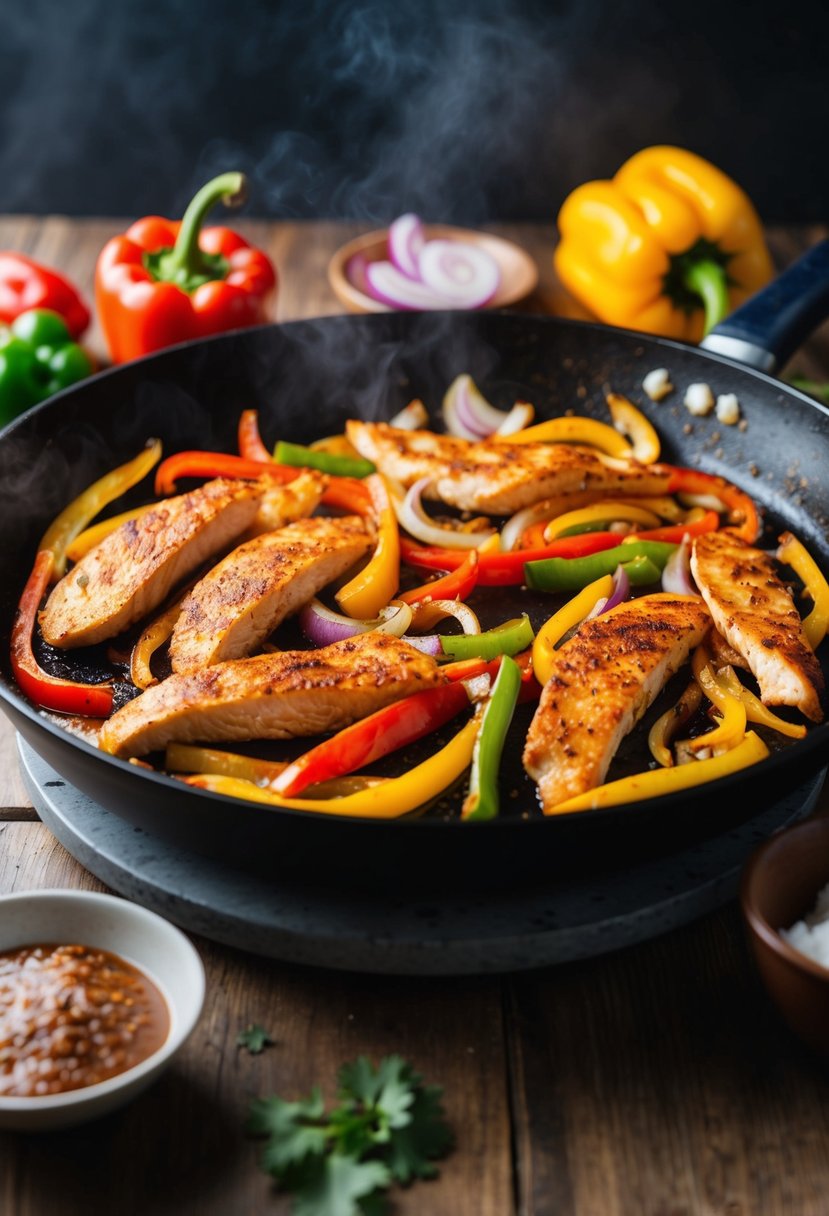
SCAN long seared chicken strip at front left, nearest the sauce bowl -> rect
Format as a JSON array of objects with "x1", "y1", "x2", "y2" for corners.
[{"x1": 98, "y1": 634, "x2": 442, "y2": 756}]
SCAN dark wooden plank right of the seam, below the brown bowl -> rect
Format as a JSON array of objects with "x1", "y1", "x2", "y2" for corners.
[{"x1": 508, "y1": 907, "x2": 829, "y2": 1216}]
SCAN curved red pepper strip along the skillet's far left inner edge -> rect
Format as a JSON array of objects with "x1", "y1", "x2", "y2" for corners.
[{"x1": 11, "y1": 548, "x2": 112, "y2": 717}]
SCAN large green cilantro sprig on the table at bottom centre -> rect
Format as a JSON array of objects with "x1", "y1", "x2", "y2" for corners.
[{"x1": 248, "y1": 1055, "x2": 452, "y2": 1216}]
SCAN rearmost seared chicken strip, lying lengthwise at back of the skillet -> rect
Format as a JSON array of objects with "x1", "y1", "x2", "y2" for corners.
[{"x1": 345, "y1": 420, "x2": 670, "y2": 516}]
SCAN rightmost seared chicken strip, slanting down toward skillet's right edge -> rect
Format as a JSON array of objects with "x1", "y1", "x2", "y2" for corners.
[{"x1": 690, "y1": 530, "x2": 824, "y2": 722}]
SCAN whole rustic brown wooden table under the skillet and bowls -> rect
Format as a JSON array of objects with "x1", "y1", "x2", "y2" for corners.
[{"x1": 0, "y1": 218, "x2": 829, "y2": 1216}]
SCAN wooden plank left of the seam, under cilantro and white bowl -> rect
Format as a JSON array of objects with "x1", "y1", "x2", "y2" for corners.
[{"x1": 0, "y1": 823, "x2": 513, "y2": 1216}]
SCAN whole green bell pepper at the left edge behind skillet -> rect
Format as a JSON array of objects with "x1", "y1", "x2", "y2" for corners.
[{"x1": 0, "y1": 308, "x2": 92, "y2": 427}]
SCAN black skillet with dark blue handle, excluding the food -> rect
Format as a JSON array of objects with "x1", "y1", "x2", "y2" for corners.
[{"x1": 0, "y1": 242, "x2": 829, "y2": 888}]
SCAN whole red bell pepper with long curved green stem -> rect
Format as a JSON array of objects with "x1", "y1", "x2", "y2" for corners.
[{"x1": 95, "y1": 173, "x2": 276, "y2": 364}]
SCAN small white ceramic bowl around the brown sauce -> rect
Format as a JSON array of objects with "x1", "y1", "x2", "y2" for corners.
[{"x1": 0, "y1": 890, "x2": 204, "y2": 1131}]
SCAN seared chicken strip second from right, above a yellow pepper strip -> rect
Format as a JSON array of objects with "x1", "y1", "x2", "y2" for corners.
[{"x1": 524, "y1": 593, "x2": 711, "y2": 811}]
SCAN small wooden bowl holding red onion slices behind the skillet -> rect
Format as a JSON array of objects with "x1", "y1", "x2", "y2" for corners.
[{"x1": 328, "y1": 224, "x2": 538, "y2": 313}]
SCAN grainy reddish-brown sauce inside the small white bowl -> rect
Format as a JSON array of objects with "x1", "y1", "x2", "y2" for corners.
[{"x1": 0, "y1": 944, "x2": 170, "y2": 1098}]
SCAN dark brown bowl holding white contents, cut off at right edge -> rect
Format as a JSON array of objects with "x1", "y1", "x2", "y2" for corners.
[{"x1": 740, "y1": 817, "x2": 829, "y2": 1057}]
